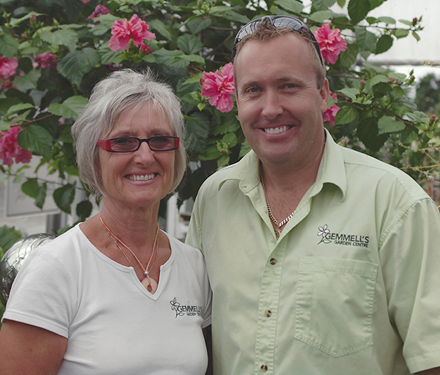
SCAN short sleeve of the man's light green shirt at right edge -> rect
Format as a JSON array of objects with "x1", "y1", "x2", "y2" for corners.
[{"x1": 380, "y1": 198, "x2": 440, "y2": 373}]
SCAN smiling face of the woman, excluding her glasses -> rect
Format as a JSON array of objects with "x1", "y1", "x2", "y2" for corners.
[{"x1": 98, "y1": 102, "x2": 176, "y2": 209}]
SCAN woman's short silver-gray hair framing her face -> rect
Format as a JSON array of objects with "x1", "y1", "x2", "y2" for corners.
[{"x1": 72, "y1": 69, "x2": 186, "y2": 198}]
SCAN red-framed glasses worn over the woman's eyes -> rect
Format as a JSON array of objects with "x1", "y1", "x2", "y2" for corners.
[{"x1": 96, "y1": 135, "x2": 179, "y2": 152}]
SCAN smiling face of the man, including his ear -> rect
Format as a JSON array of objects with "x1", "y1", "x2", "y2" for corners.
[{"x1": 234, "y1": 33, "x2": 329, "y2": 168}]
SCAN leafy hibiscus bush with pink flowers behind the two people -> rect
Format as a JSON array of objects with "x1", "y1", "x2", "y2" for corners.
[{"x1": 0, "y1": 0, "x2": 439, "y2": 231}]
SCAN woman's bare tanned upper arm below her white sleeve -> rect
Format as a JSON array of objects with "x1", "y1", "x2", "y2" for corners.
[{"x1": 0, "y1": 320, "x2": 67, "y2": 375}]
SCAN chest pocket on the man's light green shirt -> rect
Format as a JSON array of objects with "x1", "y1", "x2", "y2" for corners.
[{"x1": 295, "y1": 257, "x2": 378, "y2": 357}]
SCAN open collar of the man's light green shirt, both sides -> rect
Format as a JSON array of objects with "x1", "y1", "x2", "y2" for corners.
[{"x1": 218, "y1": 129, "x2": 347, "y2": 200}]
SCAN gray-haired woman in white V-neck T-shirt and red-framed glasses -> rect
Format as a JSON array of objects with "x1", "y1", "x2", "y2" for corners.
[{"x1": 0, "y1": 70, "x2": 211, "y2": 375}]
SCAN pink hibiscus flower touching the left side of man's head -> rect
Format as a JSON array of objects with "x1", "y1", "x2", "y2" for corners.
[{"x1": 200, "y1": 63, "x2": 235, "y2": 112}]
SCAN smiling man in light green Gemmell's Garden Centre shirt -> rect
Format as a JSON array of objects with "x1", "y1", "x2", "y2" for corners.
[{"x1": 187, "y1": 16, "x2": 440, "y2": 375}]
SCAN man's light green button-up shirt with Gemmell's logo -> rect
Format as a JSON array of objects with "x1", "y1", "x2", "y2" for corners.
[{"x1": 187, "y1": 134, "x2": 440, "y2": 375}]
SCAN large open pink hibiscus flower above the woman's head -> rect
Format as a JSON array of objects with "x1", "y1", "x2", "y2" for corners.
[{"x1": 109, "y1": 14, "x2": 156, "y2": 51}]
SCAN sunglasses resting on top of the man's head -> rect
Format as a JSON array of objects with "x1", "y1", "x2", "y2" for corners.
[{"x1": 231, "y1": 16, "x2": 324, "y2": 65}]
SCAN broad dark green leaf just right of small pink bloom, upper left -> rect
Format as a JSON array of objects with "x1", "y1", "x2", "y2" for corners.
[{"x1": 58, "y1": 48, "x2": 100, "y2": 86}]
